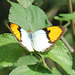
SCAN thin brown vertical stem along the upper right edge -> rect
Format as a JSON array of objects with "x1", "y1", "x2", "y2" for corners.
[{"x1": 67, "y1": 0, "x2": 75, "y2": 55}]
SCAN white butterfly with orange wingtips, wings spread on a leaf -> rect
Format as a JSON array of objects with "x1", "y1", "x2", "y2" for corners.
[{"x1": 7, "y1": 22, "x2": 66, "y2": 52}]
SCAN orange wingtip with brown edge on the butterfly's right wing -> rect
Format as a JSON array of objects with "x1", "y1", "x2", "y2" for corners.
[{"x1": 47, "y1": 26, "x2": 67, "y2": 42}]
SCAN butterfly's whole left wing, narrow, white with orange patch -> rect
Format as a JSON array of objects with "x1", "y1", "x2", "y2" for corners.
[{"x1": 7, "y1": 22, "x2": 34, "y2": 51}]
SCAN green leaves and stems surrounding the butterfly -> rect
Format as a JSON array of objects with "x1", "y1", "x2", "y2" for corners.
[{"x1": 0, "y1": 0, "x2": 75, "y2": 75}]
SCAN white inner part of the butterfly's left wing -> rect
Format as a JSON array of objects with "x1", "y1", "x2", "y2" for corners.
[{"x1": 20, "y1": 28, "x2": 34, "y2": 51}]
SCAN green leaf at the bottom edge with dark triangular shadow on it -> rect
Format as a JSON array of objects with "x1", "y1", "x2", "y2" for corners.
[{"x1": 9, "y1": 65, "x2": 52, "y2": 75}]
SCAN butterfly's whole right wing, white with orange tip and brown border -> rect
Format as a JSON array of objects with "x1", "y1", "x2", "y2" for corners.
[{"x1": 32, "y1": 26, "x2": 66, "y2": 52}]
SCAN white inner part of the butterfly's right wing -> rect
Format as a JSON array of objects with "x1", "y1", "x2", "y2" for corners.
[{"x1": 32, "y1": 30, "x2": 52, "y2": 52}]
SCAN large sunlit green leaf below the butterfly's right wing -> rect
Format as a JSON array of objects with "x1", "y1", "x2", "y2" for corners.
[{"x1": 40, "y1": 40, "x2": 72, "y2": 74}]
